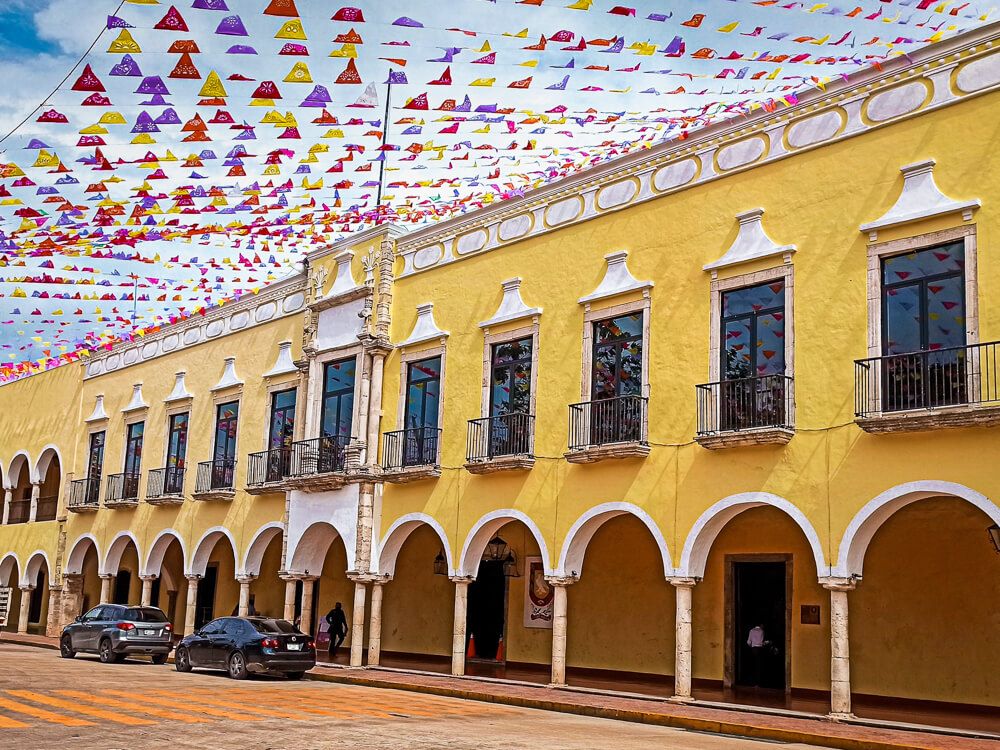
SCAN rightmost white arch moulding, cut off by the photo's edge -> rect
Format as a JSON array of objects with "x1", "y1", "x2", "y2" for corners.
[{"x1": 834, "y1": 479, "x2": 1000, "y2": 577}]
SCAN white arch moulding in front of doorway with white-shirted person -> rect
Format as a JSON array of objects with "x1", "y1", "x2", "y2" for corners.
[{"x1": 677, "y1": 492, "x2": 831, "y2": 578}]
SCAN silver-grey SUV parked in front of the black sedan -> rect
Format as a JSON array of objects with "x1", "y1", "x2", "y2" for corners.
[{"x1": 59, "y1": 604, "x2": 173, "y2": 664}]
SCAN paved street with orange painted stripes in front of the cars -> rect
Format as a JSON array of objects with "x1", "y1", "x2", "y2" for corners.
[{"x1": 0, "y1": 644, "x2": 828, "y2": 750}]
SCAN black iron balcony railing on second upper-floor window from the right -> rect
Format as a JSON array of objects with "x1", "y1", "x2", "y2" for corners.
[{"x1": 695, "y1": 375, "x2": 795, "y2": 435}]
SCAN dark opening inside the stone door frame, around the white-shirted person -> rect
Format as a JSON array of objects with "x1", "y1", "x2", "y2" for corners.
[{"x1": 732, "y1": 561, "x2": 788, "y2": 690}]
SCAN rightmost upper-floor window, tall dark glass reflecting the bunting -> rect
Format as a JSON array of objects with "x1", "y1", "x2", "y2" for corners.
[{"x1": 881, "y1": 241, "x2": 968, "y2": 411}]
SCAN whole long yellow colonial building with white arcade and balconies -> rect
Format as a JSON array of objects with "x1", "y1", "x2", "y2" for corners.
[{"x1": 0, "y1": 25, "x2": 1000, "y2": 728}]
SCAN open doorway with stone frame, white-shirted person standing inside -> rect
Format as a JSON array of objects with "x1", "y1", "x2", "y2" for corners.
[{"x1": 725, "y1": 555, "x2": 792, "y2": 691}]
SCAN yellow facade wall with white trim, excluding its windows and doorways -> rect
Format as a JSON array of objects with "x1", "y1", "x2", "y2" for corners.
[{"x1": 0, "y1": 29, "x2": 1000, "y2": 724}]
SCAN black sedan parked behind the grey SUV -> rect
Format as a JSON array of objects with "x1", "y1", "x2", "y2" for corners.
[{"x1": 174, "y1": 617, "x2": 316, "y2": 680}]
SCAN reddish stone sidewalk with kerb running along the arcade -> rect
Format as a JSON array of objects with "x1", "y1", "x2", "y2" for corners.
[{"x1": 0, "y1": 633, "x2": 1000, "y2": 750}]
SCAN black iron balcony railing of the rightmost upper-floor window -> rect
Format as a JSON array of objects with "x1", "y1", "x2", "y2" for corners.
[{"x1": 854, "y1": 341, "x2": 1000, "y2": 418}]
